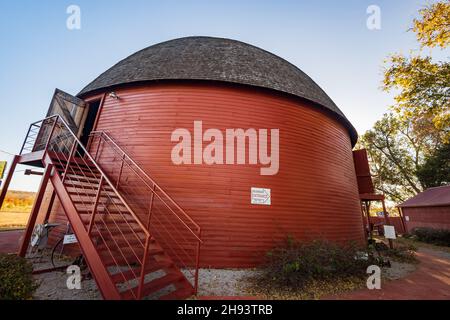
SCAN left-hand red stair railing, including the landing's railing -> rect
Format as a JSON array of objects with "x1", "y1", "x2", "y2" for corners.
[{"x1": 21, "y1": 115, "x2": 178, "y2": 299}]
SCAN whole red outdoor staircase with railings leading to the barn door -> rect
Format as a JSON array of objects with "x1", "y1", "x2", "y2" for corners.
[{"x1": 0, "y1": 115, "x2": 201, "y2": 300}]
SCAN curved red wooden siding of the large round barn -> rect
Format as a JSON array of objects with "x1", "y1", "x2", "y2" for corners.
[{"x1": 43, "y1": 83, "x2": 364, "y2": 267}]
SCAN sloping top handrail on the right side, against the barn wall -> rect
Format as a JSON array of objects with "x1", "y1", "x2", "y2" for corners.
[{"x1": 90, "y1": 131, "x2": 203, "y2": 243}]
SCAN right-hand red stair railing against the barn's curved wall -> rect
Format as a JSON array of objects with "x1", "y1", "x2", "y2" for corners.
[{"x1": 88, "y1": 131, "x2": 202, "y2": 292}]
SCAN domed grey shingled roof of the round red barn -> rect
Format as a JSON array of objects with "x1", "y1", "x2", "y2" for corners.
[{"x1": 78, "y1": 37, "x2": 358, "y2": 144}]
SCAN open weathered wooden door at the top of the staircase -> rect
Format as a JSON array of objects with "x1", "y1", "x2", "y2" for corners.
[{"x1": 33, "y1": 89, "x2": 86, "y2": 151}]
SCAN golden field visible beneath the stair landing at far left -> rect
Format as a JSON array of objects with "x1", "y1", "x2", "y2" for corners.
[{"x1": 0, "y1": 190, "x2": 35, "y2": 230}]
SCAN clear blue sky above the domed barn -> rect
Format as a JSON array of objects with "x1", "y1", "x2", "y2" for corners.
[{"x1": 0, "y1": 0, "x2": 443, "y2": 190}]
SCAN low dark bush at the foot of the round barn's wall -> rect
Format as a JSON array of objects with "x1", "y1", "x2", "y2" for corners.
[{"x1": 263, "y1": 239, "x2": 373, "y2": 289}]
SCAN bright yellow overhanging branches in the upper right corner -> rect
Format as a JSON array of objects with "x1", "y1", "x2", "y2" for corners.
[{"x1": 383, "y1": 1, "x2": 450, "y2": 142}]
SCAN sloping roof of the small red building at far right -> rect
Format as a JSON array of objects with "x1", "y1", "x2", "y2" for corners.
[{"x1": 399, "y1": 185, "x2": 450, "y2": 208}]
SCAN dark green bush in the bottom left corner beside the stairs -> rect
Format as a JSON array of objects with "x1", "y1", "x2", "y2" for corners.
[{"x1": 0, "y1": 254, "x2": 37, "y2": 300}]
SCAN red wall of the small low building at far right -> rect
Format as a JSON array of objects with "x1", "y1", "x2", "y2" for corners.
[{"x1": 402, "y1": 206, "x2": 450, "y2": 232}]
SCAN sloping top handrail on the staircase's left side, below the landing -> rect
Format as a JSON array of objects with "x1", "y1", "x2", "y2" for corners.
[{"x1": 33, "y1": 115, "x2": 150, "y2": 238}]
